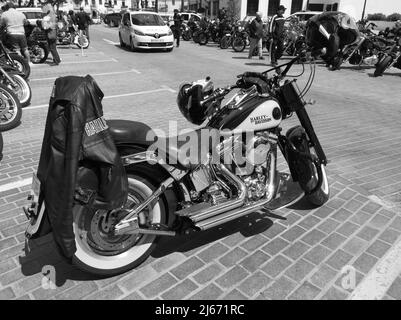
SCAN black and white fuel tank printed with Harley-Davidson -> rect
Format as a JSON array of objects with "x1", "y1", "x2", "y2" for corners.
[{"x1": 208, "y1": 96, "x2": 282, "y2": 131}]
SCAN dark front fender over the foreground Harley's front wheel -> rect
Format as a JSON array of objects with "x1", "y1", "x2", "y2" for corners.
[{"x1": 285, "y1": 126, "x2": 318, "y2": 193}]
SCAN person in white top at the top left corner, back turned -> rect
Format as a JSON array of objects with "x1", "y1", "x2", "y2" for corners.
[{"x1": 0, "y1": 2, "x2": 30, "y2": 63}]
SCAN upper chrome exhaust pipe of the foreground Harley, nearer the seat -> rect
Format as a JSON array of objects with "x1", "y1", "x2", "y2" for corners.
[{"x1": 176, "y1": 164, "x2": 246, "y2": 223}]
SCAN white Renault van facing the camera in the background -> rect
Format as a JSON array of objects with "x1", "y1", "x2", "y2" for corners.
[{"x1": 118, "y1": 11, "x2": 174, "y2": 51}]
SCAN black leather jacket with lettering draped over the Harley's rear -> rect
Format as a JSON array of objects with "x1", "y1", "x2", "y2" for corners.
[{"x1": 37, "y1": 75, "x2": 128, "y2": 257}]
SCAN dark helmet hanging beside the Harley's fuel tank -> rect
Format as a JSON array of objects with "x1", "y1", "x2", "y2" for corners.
[{"x1": 177, "y1": 78, "x2": 213, "y2": 125}]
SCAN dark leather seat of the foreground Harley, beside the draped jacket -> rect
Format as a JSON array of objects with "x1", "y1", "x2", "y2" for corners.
[{"x1": 107, "y1": 120, "x2": 220, "y2": 170}]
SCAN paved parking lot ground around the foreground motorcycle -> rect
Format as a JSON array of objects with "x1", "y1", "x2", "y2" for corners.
[{"x1": 0, "y1": 25, "x2": 401, "y2": 299}]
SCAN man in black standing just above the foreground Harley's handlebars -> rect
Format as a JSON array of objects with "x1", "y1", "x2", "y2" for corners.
[{"x1": 269, "y1": 5, "x2": 287, "y2": 66}]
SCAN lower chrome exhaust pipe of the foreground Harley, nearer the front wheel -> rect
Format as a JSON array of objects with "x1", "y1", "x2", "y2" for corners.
[{"x1": 195, "y1": 144, "x2": 278, "y2": 230}]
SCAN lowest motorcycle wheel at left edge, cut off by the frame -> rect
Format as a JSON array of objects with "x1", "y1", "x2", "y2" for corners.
[{"x1": 0, "y1": 84, "x2": 22, "y2": 131}]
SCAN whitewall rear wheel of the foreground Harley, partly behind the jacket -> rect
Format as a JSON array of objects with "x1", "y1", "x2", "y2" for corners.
[{"x1": 73, "y1": 174, "x2": 166, "y2": 276}]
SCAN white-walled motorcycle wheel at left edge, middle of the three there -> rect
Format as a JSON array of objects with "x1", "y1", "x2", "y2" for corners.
[{"x1": 0, "y1": 66, "x2": 32, "y2": 108}]
